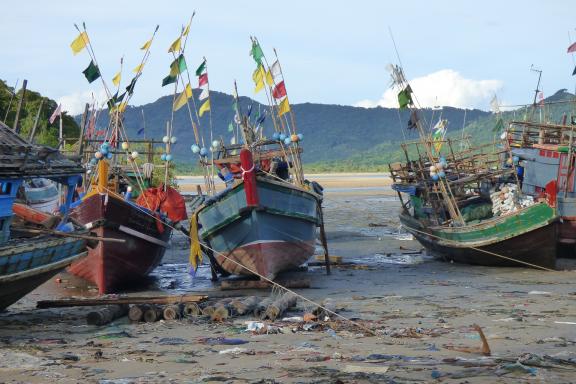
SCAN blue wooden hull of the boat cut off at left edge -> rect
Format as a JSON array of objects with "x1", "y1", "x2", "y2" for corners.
[{"x1": 0, "y1": 236, "x2": 86, "y2": 310}]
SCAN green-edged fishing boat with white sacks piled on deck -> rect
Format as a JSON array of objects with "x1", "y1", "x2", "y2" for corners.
[{"x1": 389, "y1": 66, "x2": 558, "y2": 269}]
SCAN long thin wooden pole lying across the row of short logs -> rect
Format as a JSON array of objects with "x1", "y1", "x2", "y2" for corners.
[{"x1": 36, "y1": 294, "x2": 208, "y2": 308}]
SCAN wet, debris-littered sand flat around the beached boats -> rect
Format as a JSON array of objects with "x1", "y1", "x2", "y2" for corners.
[{"x1": 0, "y1": 178, "x2": 576, "y2": 383}]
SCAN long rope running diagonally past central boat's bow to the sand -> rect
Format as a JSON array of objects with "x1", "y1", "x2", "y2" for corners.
[{"x1": 98, "y1": 188, "x2": 409, "y2": 345}]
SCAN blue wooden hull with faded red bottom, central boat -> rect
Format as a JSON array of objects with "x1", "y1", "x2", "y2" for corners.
[{"x1": 198, "y1": 179, "x2": 320, "y2": 279}]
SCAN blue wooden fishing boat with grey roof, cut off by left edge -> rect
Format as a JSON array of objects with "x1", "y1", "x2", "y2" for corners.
[{"x1": 0, "y1": 123, "x2": 86, "y2": 310}]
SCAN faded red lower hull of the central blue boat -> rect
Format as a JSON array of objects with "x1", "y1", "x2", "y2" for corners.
[{"x1": 216, "y1": 241, "x2": 315, "y2": 279}]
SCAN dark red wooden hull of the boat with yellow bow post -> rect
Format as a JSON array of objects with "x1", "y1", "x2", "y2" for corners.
[{"x1": 68, "y1": 195, "x2": 171, "y2": 294}]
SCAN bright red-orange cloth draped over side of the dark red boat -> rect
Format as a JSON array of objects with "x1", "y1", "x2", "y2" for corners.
[{"x1": 136, "y1": 184, "x2": 188, "y2": 223}]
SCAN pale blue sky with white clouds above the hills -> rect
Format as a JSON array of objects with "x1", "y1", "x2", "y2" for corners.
[{"x1": 0, "y1": 0, "x2": 576, "y2": 114}]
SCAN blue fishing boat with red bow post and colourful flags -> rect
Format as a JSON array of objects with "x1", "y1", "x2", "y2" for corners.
[{"x1": 191, "y1": 38, "x2": 322, "y2": 279}]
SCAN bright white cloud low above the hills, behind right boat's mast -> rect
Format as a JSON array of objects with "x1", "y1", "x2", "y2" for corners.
[{"x1": 355, "y1": 69, "x2": 503, "y2": 109}]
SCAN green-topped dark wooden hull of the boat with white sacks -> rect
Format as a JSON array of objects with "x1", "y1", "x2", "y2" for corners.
[{"x1": 400, "y1": 203, "x2": 557, "y2": 268}]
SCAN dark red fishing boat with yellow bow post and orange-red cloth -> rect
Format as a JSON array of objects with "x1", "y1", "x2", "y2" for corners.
[{"x1": 68, "y1": 23, "x2": 187, "y2": 294}]
